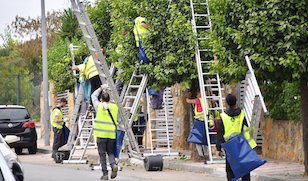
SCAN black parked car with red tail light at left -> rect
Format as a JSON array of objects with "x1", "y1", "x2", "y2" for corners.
[{"x1": 0, "y1": 105, "x2": 37, "y2": 154}]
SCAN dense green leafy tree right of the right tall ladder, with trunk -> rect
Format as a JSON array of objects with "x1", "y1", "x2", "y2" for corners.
[{"x1": 209, "y1": 0, "x2": 308, "y2": 175}]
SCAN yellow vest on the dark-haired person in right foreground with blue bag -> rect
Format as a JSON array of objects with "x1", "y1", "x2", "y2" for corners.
[{"x1": 221, "y1": 110, "x2": 257, "y2": 148}]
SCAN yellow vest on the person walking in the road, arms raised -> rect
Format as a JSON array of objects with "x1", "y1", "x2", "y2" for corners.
[{"x1": 93, "y1": 103, "x2": 119, "y2": 139}]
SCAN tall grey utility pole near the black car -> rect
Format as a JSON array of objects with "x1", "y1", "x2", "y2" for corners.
[{"x1": 41, "y1": 0, "x2": 50, "y2": 146}]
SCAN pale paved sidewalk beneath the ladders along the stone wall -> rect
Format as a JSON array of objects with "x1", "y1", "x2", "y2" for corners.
[{"x1": 38, "y1": 134, "x2": 308, "y2": 181}]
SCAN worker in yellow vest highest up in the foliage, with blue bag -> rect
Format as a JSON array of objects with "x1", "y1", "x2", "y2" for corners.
[{"x1": 134, "y1": 16, "x2": 150, "y2": 64}]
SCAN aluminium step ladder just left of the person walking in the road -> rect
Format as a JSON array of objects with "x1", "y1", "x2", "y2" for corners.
[{"x1": 63, "y1": 111, "x2": 95, "y2": 164}]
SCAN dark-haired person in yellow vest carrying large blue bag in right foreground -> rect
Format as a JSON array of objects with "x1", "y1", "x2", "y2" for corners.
[{"x1": 216, "y1": 94, "x2": 257, "y2": 181}]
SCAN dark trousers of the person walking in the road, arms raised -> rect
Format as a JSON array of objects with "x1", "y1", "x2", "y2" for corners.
[{"x1": 97, "y1": 138, "x2": 116, "y2": 175}]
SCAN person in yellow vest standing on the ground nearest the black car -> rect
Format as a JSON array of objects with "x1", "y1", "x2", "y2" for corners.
[{"x1": 50, "y1": 98, "x2": 67, "y2": 158}]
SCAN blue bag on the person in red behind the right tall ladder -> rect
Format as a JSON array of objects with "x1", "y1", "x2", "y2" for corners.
[{"x1": 186, "y1": 120, "x2": 216, "y2": 145}]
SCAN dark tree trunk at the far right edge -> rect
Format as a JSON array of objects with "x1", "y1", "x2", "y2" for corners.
[{"x1": 300, "y1": 78, "x2": 308, "y2": 176}]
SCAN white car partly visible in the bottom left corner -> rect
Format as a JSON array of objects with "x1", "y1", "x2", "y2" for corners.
[{"x1": 0, "y1": 134, "x2": 24, "y2": 181}]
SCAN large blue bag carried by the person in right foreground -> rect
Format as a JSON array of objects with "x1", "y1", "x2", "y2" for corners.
[{"x1": 222, "y1": 134, "x2": 266, "y2": 180}]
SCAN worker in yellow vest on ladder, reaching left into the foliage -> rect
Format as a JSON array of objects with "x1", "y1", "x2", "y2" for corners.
[{"x1": 72, "y1": 56, "x2": 102, "y2": 97}]
